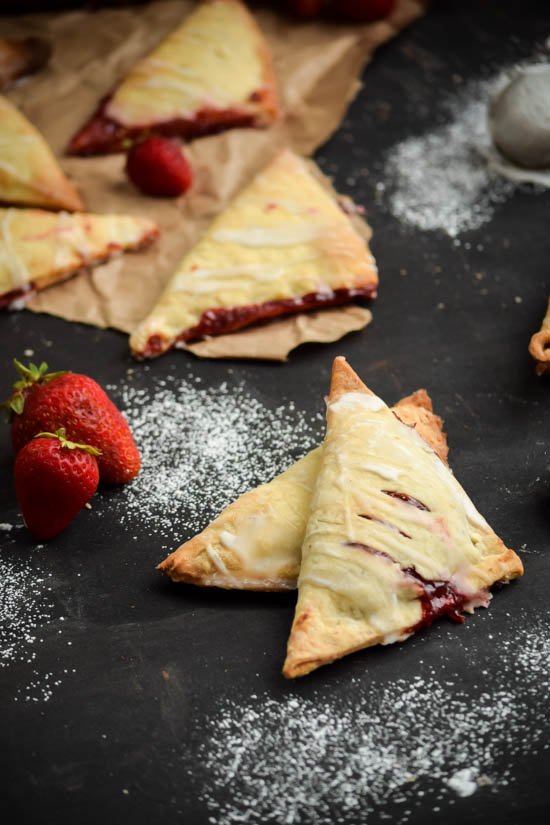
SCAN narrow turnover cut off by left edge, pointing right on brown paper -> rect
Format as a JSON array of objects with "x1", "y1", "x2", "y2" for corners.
[{"x1": 0, "y1": 209, "x2": 158, "y2": 307}]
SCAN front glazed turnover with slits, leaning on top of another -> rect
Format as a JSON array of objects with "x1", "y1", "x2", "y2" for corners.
[{"x1": 283, "y1": 358, "x2": 523, "y2": 678}]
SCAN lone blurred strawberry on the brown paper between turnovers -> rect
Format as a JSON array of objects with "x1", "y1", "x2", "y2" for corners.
[{"x1": 126, "y1": 136, "x2": 193, "y2": 198}]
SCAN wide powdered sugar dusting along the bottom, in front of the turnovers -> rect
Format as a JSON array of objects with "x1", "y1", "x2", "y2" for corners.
[{"x1": 193, "y1": 623, "x2": 550, "y2": 825}]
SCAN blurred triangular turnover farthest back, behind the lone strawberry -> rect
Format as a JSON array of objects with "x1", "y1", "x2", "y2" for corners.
[{"x1": 69, "y1": 0, "x2": 280, "y2": 155}]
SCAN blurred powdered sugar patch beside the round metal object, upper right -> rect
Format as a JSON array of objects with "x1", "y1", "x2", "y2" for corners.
[{"x1": 384, "y1": 75, "x2": 515, "y2": 238}]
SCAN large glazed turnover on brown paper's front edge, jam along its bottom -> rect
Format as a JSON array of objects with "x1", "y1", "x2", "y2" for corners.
[{"x1": 130, "y1": 151, "x2": 378, "y2": 358}]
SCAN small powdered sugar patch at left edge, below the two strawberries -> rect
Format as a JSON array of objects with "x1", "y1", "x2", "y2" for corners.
[{"x1": 0, "y1": 549, "x2": 53, "y2": 668}]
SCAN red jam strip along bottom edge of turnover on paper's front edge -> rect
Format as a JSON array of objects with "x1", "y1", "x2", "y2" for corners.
[{"x1": 140, "y1": 286, "x2": 376, "y2": 357}]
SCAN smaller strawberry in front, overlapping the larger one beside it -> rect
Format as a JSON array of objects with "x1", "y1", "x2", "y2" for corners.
[{"x1": 15, "y1": 428, "x2": 99, "y2": 541}]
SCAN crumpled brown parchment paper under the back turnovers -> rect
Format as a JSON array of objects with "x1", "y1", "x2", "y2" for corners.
[{"x1": 0, "y1": 0, "x2": 426, "y2": 360}]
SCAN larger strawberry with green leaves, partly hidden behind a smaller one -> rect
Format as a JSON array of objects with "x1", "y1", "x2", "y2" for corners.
[{"x1": 6, "y1": 361, "x2": 141, "y2": 484}]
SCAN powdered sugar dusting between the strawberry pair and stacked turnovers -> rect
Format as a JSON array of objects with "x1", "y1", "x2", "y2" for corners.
[{"x1": 103, "y1": 376, "x2": 323, "y2": 541}]
